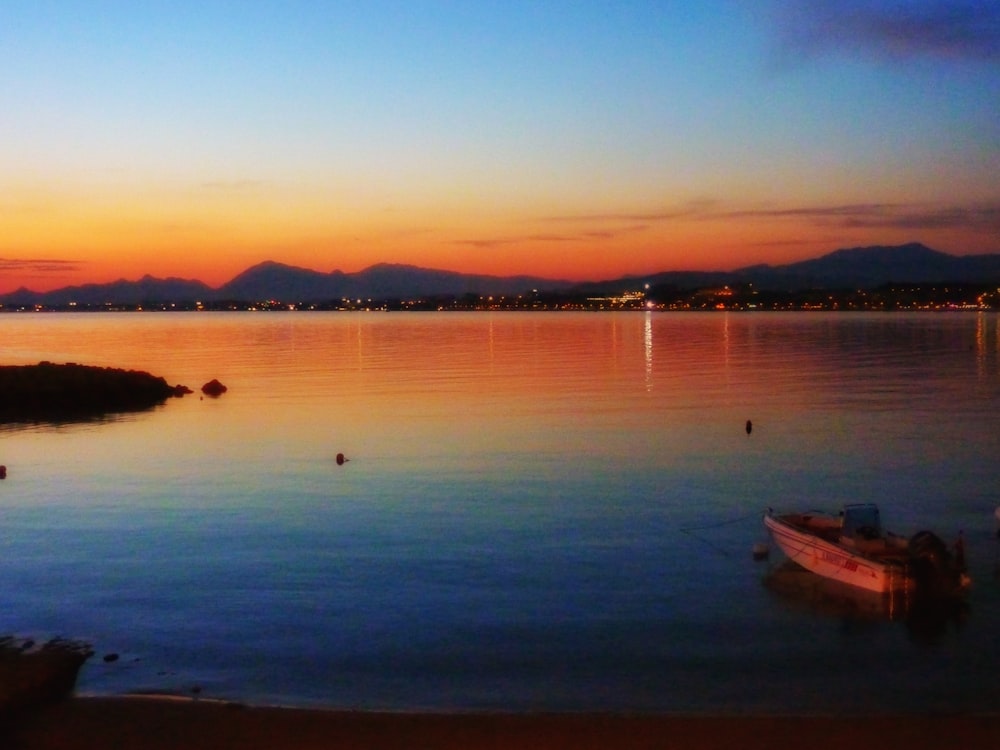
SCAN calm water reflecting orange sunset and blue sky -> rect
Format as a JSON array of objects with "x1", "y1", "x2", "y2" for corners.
[{"x1": 0, "y1": 313, "x2": 1000, "y2": 713}]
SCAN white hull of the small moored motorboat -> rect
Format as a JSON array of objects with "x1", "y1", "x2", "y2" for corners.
[{"x1": 764, "y1": 514, "x2": 914, "y2": 593}]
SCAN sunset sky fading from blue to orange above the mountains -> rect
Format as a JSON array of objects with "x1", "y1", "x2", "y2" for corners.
[{"x1": 0, "y1": 0, "x2": 1000, "y2": 292}]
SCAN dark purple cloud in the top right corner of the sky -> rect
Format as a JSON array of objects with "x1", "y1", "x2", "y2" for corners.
[{"x1": 775, "y1": 0, "x2": 1000, "y2": 62}]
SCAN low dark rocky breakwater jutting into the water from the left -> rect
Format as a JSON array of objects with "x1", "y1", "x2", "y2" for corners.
[{"x1": 0, "y1": 362, "x2": 191, "y2": 422}]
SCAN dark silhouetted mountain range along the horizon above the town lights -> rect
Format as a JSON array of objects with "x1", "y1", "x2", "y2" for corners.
[{"x1": 0, "y1": 243, "x2": 1000, "y2": 307}]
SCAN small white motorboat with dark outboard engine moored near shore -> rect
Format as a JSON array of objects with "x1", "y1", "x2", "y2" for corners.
[{"x1": 764, "y1": 503, "x2": 969, "y2": 595}]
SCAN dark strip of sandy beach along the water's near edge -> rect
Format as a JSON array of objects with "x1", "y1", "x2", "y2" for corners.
[{"x1": 0, "y1": 698, "x2": 1000, "y2": 750}]
